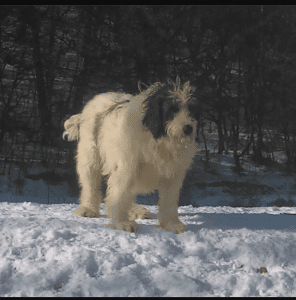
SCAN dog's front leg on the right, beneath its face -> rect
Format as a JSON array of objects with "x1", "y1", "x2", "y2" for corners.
[{"x1": 158, "y1": 179, "x2": 186, "y2": 233}]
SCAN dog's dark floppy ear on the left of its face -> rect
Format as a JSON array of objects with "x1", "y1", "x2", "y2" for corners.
[{"x1": 142, "y1": 95, "x2": 166, "y2": 140}]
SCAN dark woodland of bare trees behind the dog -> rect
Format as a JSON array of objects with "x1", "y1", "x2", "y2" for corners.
[{"x1": 0, "y1": 5, "x2": 296, "y2": 199}]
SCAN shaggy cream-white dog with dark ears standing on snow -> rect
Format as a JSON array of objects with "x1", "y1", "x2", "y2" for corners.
[{"x1": 63, "y1": 77, "x2": 199, "y2": 234}]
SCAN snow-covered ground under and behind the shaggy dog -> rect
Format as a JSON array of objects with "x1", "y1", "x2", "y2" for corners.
[{"x1": 0, "y1": 128, "x2": 296, "y2": 296}]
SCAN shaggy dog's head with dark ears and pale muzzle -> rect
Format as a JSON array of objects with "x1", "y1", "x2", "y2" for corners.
[{"x1": 142, "y1": 77, "x2": 198, "y2": 144}]
